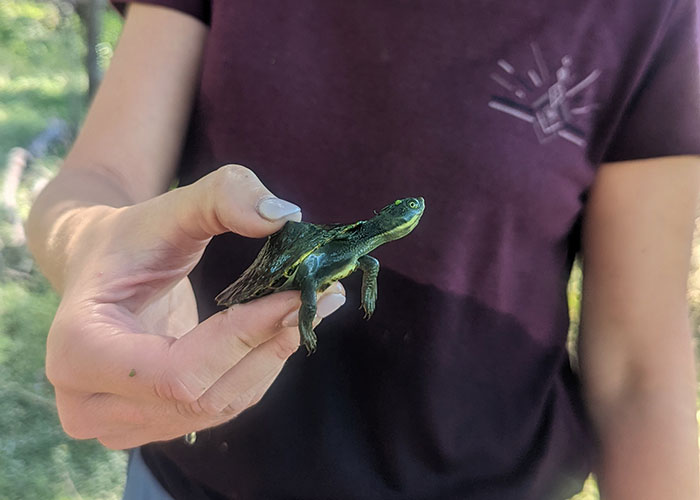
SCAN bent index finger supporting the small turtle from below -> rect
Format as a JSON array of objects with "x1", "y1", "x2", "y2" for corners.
[{"x1": 46, "y1": 292, "x2": 300, "y2": 402}]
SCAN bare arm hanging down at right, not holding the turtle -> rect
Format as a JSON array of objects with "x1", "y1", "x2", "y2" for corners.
[{"x1": 579, "y1": 156, "x2": 700, "y2": 500}]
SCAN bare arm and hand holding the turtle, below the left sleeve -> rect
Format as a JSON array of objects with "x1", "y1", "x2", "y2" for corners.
[{"x1": 27, "y1": 6, "x2": 344, "y2": 448}]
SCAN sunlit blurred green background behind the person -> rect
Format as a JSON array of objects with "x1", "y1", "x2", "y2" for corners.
[{"x1": 0, "y1": 0, "x2": 700, "y2": 500}]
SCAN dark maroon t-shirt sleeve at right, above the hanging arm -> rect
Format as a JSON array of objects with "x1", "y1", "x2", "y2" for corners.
[{"x1": 603, "y1": 0, "x2": 700, "y2": 161}]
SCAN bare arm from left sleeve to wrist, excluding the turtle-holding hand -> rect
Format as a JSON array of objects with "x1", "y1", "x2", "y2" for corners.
[{"x1": 27, "y1": 4, "x2": 208, "y2": 291}]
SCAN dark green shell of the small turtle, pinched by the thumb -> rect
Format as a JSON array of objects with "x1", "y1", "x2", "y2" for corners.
[{"x1": 215, "y1": 221, "x2": 365, "y2": 307}]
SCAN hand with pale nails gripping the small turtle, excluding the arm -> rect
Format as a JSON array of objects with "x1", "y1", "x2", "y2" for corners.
[{"x1": 46, "y1": 165, "x2": 344, "y2": 448}]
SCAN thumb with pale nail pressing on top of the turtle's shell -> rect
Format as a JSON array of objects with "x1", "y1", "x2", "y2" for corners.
[{"x1": 150, "y1": 165, "x2": 301, "y2": 246}]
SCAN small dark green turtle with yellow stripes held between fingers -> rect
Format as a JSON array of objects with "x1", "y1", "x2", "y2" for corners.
[{"x1": 215, "y1": 197, "x2": 425, "y2": 354}]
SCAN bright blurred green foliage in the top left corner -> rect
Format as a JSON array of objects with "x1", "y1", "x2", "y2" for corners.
[{"x1": 0, "y1": 1, "x2": 82, "y2": 157}]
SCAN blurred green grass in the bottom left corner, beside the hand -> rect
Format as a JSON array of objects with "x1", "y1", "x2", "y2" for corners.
[{"x1": 0, "y1": 281, "x2": 125, "y2": 500}]
